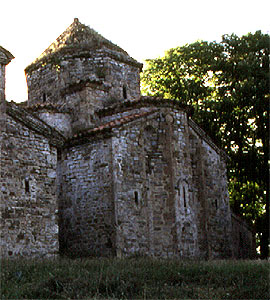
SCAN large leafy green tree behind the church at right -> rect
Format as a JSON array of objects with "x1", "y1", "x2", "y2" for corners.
[{"x1": 142, "y1": 31, "x2": 270, "y2": 258}]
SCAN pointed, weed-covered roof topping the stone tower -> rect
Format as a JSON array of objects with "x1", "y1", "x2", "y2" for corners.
[{"x1": 26, "y1": 18, "x2": 141, "y2": 71}]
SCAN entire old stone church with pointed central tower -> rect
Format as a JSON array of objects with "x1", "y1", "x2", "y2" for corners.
[{"x1": 0, "y1": 19, "x2": 254, "y2": 259}]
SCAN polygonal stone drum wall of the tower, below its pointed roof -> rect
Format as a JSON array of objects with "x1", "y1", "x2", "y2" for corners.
[{"x1": 27, "y1": 49, "x2": 140, "y2": 129}]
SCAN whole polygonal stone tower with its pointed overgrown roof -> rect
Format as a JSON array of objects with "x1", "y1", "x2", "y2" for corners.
[{"x1": 25, "y1": 19, "x2": 142, "y2": 127}]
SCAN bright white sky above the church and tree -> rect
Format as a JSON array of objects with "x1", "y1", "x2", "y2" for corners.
[{"x1": 0, "y1": 0, "x2": 270, "y2": 102}]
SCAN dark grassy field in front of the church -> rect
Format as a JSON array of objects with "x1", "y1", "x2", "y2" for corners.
[{"x1": 1, "y1": 258, "x2": 270, "y2": 299}]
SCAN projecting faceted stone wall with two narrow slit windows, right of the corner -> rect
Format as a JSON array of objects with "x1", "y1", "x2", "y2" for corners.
[{"x1": 109, "y1": 108, "x2": 231, "y2": 258}]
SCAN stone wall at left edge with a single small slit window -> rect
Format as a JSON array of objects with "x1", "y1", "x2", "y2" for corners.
[{"x1": 0, "y1": 116, "x2": 58, "y2": 257}]
